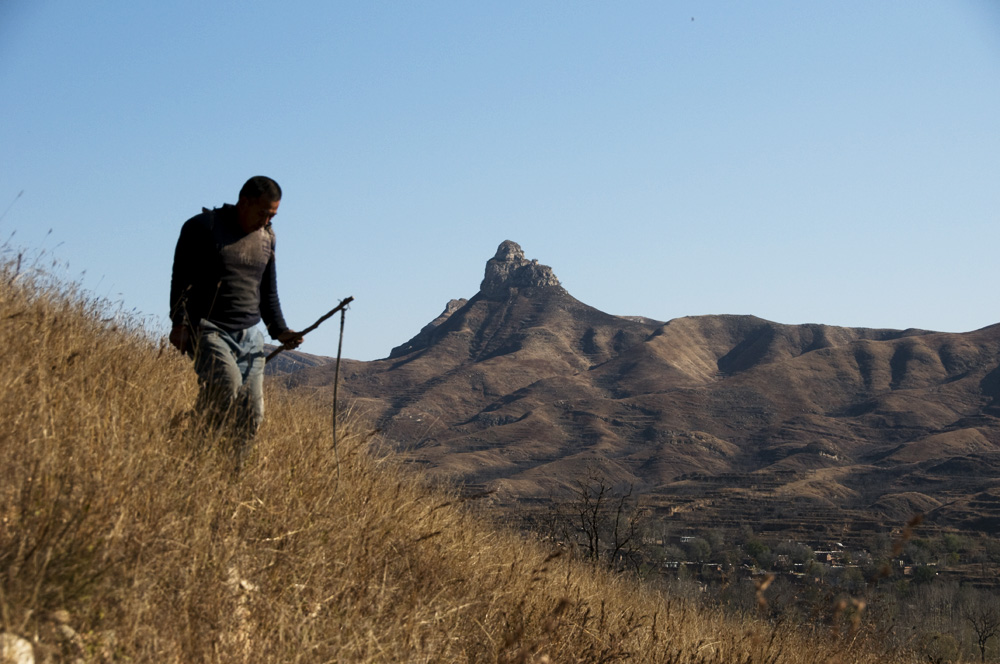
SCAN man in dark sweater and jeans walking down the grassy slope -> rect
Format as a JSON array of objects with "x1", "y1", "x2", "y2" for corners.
[{"x1": 170, "y1": 175, "x2": 302, "y2": 467}]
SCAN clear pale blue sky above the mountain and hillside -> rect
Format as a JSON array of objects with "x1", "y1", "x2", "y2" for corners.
[{"x1": 0, "y1": 0, "x2": 1000, "y2": 360}]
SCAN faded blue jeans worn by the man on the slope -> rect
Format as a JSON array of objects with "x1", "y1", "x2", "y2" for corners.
[{"x1": 194, "y1": 319, "x2": 265, "y2": 462}]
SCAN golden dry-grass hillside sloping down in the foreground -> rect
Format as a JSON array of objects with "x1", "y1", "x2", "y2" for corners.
[{"x1": 0, "y1": 261, "x2": 909, "y2": 664}]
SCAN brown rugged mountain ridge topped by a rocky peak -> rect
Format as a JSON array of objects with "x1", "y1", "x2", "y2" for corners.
[{"x1": 283, "y1": 241, "x2": 1000, "y2": 536}]
